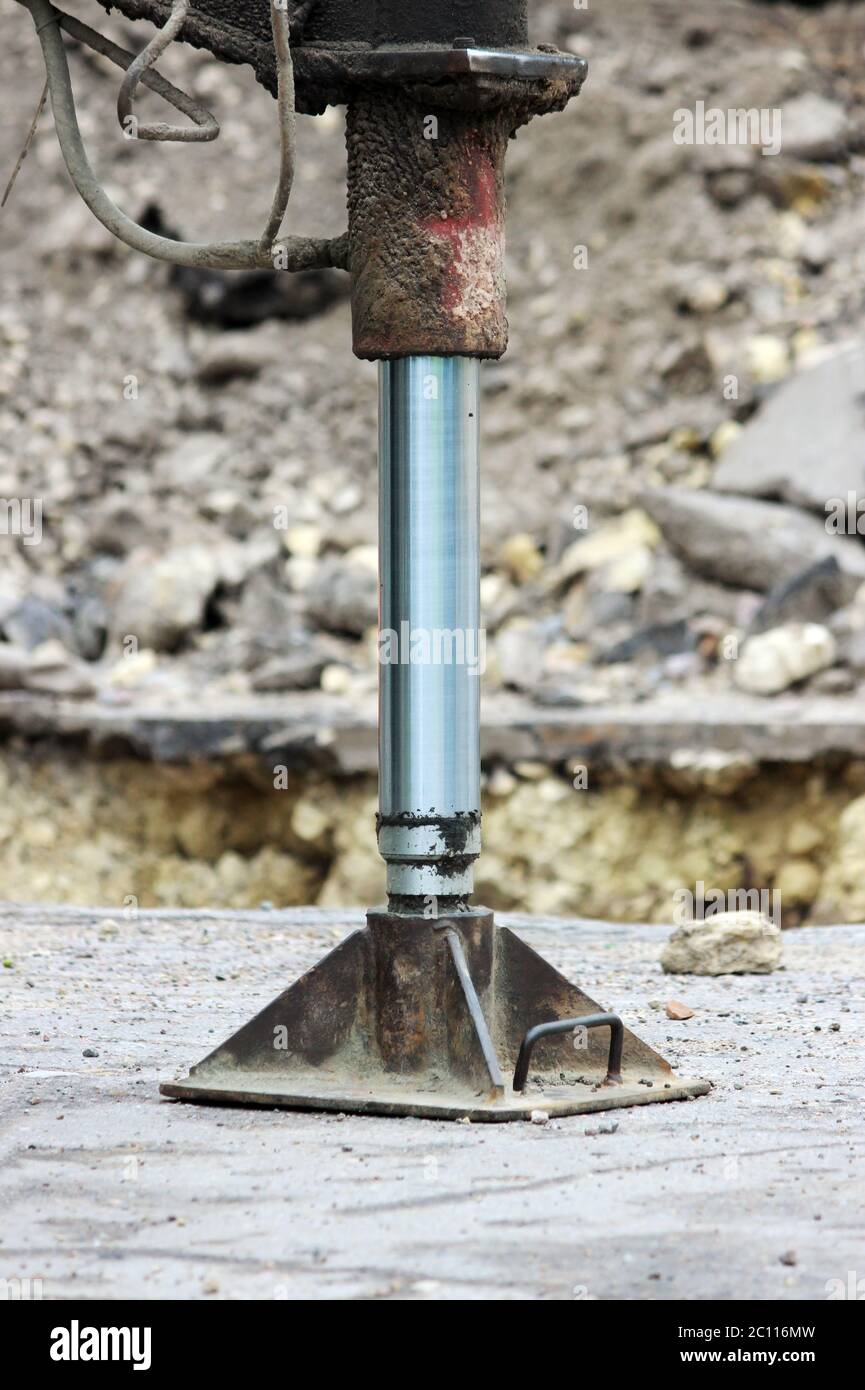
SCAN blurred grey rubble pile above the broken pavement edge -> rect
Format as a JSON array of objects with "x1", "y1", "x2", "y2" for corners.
[{"x1": 0, "y1": 3, "x2": 865, "y2": 706}]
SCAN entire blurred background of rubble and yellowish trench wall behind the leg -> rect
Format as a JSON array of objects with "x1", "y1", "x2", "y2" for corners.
[{"x1": 0, "y1": 0, "x2": 865, "y2": 924}]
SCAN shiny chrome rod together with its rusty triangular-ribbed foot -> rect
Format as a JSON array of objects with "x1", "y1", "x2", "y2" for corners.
[{"x1": 161, "y1": 357, "x2": 708, "y2": 1120}]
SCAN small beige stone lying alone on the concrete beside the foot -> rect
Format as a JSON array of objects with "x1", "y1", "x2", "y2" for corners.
[{"x1": 661, "y1": 912, "x2": 782, "y2": 974}]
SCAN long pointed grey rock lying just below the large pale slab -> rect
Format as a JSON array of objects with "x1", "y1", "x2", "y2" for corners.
[{"x1": 641, "y1": 488, "x2": 865, "y2": 592}]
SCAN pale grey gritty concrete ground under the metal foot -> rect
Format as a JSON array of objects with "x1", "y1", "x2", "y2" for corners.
[{"x1": 0, "y1": 908, "x2": 865, "y2": 1300}]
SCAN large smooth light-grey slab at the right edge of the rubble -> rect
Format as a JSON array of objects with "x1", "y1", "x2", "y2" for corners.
[{"x1": 712, "y1": 349, "x2": 865, "y2": 517}]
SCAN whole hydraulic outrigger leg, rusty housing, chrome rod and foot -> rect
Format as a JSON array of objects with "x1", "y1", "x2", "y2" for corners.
[{"x1": 161, "y1": 3, "x2": 708, "y2": 1120}]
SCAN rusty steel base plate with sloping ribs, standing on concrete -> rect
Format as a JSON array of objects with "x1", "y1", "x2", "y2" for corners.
[{"x1": 160, "y1": 909, "x2": 711, "y2": 1123}]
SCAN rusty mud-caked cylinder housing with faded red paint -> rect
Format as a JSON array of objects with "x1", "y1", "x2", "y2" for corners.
[{"x1": 348, "y1": 90, "x2": 513, "y2": 360}]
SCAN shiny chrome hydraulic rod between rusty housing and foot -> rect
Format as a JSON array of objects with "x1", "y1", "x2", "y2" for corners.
[{"x1": 378, "y1": 357, "x2": 485, "y2": 912}]
